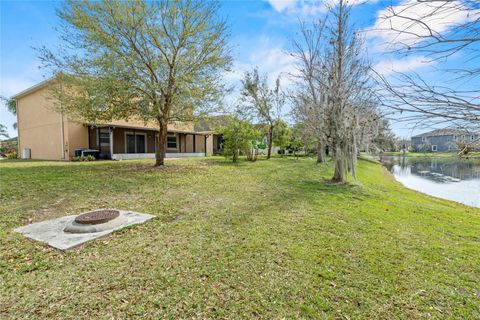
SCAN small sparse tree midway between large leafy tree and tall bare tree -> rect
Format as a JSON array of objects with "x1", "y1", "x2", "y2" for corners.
[{"x1": 241, "y1": 68, "x2": 285, "y2": 159}]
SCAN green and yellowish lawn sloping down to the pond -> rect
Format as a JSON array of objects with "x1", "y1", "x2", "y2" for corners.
[{"x1": 0, "y1": 158, "x2": 480, "y2": 319}]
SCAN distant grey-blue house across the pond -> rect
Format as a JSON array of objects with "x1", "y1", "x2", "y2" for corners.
[{"x1": 411, "y1": 129, "x2": 480, "y2": 152}]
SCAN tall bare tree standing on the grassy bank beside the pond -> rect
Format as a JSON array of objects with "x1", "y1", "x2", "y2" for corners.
[{"x1": 293, "y1": 0, "x2": 380, "y2": 182}]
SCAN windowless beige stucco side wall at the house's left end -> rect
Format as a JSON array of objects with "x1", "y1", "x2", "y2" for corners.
[{"x1": 17, "y1": 88, "x2": 62, "y2": 160}]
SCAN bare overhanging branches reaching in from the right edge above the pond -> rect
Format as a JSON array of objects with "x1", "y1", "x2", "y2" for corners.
[{"x1": 374, "y1": 0, "x2": 480, "y2": 130}]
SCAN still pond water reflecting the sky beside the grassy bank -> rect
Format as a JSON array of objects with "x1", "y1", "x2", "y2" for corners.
[{"x1": 380, "y1": 156, "x2": 480, "y2": 208}]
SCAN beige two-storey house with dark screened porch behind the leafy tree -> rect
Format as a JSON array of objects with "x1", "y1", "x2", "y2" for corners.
[{"x1": 12, "y1": 80, "x2": 213, "y2": 160}]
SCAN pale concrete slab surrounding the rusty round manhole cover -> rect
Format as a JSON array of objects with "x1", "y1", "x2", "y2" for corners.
[{"x1": 15, "y1": 209, "x2": 155, "y2": 250}]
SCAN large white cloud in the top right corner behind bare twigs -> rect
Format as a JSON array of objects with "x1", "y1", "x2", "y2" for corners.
[{"x1": 368, "y1": 0, "x2": 480, "y2": 50}]
